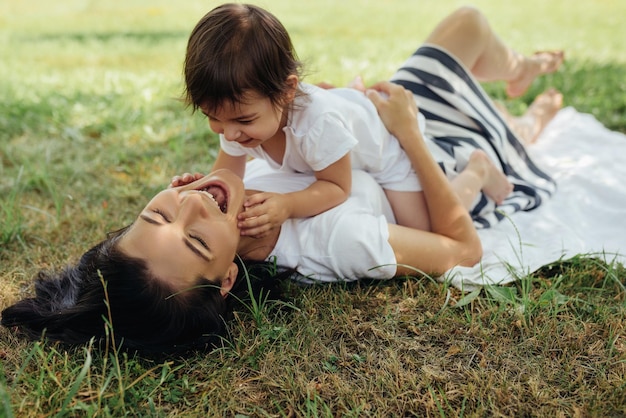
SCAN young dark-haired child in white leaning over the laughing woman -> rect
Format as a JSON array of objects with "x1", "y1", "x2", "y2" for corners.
[{"x1": 184, "y1": 4, "x2": 512, "y2": 236}]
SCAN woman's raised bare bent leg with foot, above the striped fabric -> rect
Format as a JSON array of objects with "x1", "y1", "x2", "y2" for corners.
[{"x1": 426, "y1": 7, "x2": 563, "y2": 97}]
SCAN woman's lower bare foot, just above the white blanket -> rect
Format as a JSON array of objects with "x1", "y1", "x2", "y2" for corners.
[{"x1": 497, "y1": 89, "x2": 563, "y2": 145}]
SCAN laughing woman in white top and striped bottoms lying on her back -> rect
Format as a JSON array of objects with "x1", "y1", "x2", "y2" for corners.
[{"x1": 2, "y1": 8, "x2": 562, "y2": 351}]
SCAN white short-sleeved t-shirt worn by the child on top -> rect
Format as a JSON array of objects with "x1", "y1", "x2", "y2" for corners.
[{"x1": 220, "y1": 83, "x2": 425, "y2": 191}]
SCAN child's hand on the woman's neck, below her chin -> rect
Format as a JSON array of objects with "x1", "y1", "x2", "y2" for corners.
[{"x1": 239, "y1": 192, "x2": 291, "y2": 238}]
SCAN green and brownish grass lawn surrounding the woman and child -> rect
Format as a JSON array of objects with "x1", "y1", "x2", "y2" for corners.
[{"x1": 0, "y1": 0, "x2": 626, "y2": 417}]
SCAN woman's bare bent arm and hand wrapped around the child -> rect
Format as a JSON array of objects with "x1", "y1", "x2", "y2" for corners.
[{"x1": 367, "y1": 82, "x2": 482, "y2": 275}]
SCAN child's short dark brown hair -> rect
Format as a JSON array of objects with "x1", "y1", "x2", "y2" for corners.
[{"x1": 184, "y1": 3, "x2": 301, "y2": 112}]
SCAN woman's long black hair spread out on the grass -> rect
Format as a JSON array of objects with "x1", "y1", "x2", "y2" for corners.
[{"x1": 1, "y1": 230, "x2": 282, "y2": 352}]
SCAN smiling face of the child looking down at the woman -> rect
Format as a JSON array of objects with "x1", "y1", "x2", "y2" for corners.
[{"x1": 200, "y1": 92, "x2": 287, "y2": 148}]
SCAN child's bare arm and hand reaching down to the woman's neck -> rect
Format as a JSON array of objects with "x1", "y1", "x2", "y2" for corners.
[{"x1": 239, "y1": 154, "x2": 352, "y2": 237}]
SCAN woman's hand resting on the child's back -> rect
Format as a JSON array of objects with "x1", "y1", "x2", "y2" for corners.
[{"x1": 365, "y1": 81, "x2": 421, "y2": 143}]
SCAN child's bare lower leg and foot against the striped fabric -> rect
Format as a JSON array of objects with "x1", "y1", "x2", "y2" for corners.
[{"x1": 451, "y1": 150, "x2": 513, "y2": 210}]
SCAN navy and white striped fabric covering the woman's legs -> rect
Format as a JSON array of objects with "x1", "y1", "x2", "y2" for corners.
[{"x1": 391, "y1": 46, "x2": 556, "y2": 228}]
